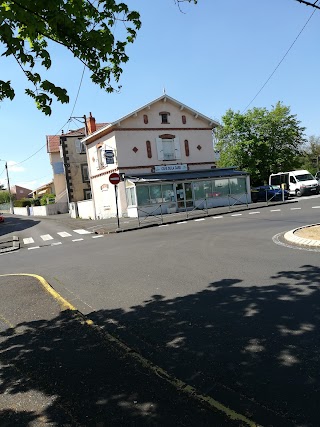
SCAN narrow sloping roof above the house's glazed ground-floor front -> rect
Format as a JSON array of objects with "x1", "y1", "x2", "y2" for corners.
[{"x1": 125, "y1": 168, "x2": 248, "y2": 183}]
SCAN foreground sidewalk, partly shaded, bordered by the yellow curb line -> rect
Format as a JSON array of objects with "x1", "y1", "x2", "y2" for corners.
[{"x1": 0, "y1": 275, "x2": 248, "y2": 427}]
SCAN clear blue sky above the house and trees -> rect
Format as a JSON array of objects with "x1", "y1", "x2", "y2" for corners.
[{"x1": 0, "y1": 0, "x2": 320, "y2": 190}]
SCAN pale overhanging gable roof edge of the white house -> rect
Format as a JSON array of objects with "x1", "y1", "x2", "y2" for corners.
[{"x1": 83, "y1": 94, "x2": 219, "y2": 142}]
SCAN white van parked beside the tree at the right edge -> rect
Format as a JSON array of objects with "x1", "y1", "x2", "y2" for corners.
[{"x1": 269, "y1": 170, "x2": 320, "y2": 197}]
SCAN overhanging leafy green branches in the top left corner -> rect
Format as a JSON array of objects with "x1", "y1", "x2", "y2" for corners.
[{"x1": 0, "y1": 0, "x2": 197, "y2": 115}]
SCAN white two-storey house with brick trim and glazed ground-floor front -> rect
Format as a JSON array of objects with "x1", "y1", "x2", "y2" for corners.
[{"x1": 82, "y1": 95, "x2": 250, "y2": 218}]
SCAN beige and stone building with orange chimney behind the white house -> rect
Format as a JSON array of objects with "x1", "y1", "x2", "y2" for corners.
[{"x1": 46, "y1": 113, "x2": 107, "y2": 203}]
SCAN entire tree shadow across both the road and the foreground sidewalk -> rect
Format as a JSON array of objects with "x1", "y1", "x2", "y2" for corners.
[{"x1": 0, "y1": 265, "x2": 320, "y2": 426}]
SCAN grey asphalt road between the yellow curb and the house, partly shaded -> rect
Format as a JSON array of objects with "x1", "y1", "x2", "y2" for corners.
[{"x1": 0, "y1": 198, "x2": 320, "y2": 426}]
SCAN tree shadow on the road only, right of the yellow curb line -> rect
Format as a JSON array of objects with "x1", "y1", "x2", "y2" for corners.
[{"x1": 90, "y1": 265, "x2": 320, "y2": 426}]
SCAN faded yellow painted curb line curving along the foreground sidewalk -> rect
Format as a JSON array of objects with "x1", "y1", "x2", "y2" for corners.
[{"x1": 0, "y1": 273, "x2": 259, "y2": 427}]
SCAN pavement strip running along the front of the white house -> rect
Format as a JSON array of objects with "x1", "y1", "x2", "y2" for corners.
[{"x1": 25, "y1": 200, "x2": 297, "y2": 234}]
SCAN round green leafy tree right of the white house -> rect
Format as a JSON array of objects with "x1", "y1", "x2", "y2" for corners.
[{"x1": 216, "y1": 102, "x2": 306, "y2": 185}]
